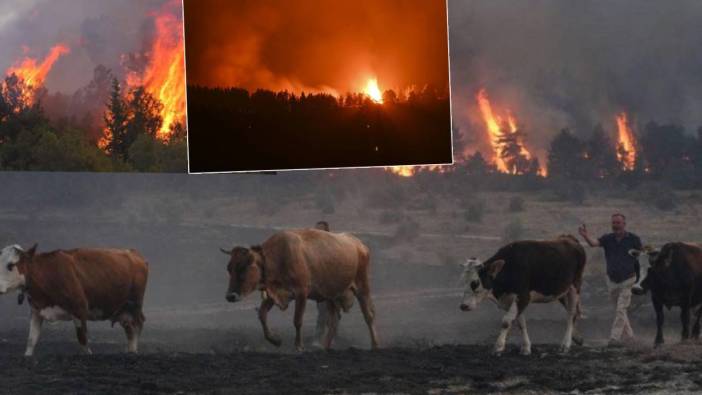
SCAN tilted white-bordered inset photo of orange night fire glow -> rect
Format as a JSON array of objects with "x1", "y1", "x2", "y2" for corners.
[{"x1": 184, "y1": 0, "x2": 453, "y2": 173}]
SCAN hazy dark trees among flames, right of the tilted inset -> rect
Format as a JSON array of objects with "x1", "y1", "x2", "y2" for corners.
[{"x1": 462, "y1": 121, "x2": 702, "y2": 188}]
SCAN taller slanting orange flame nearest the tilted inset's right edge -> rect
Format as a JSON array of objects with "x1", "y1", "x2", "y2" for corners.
[{"x1": 476, "y1": 89, "x2": 545, "y2": 175}]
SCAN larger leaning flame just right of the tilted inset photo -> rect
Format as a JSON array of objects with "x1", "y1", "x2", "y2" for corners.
[{"x1": 476, "y1": 89, "x2": 545, "y2": 175}]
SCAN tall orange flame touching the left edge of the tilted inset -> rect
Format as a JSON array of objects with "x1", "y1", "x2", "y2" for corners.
[{"x1": 127, "y1": 1, "x2": 185, "y2": 140}]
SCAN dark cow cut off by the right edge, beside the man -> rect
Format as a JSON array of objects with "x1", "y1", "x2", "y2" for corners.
[{"x1": 629, "y1": 242, "x2": 702, "y2": 346}]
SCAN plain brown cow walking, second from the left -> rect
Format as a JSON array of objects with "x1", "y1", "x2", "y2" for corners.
[{"x1": 221, "y1": 229, "x2": 378, "y2": 350}]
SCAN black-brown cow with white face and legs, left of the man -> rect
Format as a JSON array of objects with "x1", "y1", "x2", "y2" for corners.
[{"x1": 460, "y1": 236, "x2": 586, "y2": 355}]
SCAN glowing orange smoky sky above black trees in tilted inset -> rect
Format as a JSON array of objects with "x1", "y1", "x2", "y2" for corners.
[{"x1": 185, "y1": 0, "x2": 448, "y2": 93}]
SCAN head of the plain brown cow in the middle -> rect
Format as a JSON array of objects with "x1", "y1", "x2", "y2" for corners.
[{"x1": 220, "y1": 247, "x2": 263, "y2": 303}]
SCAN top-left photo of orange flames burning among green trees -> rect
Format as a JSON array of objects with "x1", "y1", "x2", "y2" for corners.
[{"x1": 0, "y1": 0, "x2": 187, "y2": 173}]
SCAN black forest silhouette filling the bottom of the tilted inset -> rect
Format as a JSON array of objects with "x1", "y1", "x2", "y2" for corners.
[{"x1": 188, "y1": 86, "x2": 451, "y2": 171}]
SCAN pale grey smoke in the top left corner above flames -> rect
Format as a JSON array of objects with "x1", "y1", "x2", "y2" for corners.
[{"x1": 0, "y1": 0, "x2": 165, "y2": 93}]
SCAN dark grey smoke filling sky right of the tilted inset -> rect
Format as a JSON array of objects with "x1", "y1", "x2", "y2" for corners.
[{"x1": 449, "y1": 0, "x2": 702, "y2": 156}]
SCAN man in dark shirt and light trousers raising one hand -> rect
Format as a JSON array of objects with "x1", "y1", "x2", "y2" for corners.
[{"x1": 578, "y1": 213, "x2": 642, "y2": 346}]
